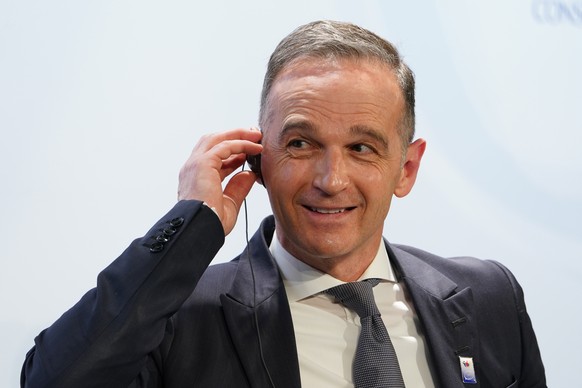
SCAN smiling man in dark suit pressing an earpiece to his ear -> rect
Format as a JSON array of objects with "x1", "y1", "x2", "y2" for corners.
[{"x1": 22, "y1": 22, "x2": 546, "y2": 388}]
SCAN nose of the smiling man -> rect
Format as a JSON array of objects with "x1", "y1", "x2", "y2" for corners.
[{"x1": 313, "y1": 150, "x2": 350, "y2": 195}]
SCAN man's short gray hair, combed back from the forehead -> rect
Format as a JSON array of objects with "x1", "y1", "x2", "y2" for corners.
[{"x1": 259, "y1": 21, "x2": 415, "y2": 151}]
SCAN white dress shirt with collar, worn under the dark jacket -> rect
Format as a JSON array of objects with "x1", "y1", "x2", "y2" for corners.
[{"x1": 270, "y1": 235, "x2": 434, "y2": 388}]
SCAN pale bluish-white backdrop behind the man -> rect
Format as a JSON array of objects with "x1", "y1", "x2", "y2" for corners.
[{"x1": 0, "y1": 0, "x2": 582, "y2": 387}]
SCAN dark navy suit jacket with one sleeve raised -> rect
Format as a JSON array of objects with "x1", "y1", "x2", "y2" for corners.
[{"x1": 22, "y1": 201, "x2": 546, "y2": 388}]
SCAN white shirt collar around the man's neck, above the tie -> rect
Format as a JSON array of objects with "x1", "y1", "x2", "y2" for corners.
[{"x1": 269, "y1": 233, "x2": 396, "y2": 302}]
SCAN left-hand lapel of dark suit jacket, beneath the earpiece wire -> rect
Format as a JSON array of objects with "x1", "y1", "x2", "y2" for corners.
[{"x1": 221, "y1": 218, "x2": 301, "y2": 388}]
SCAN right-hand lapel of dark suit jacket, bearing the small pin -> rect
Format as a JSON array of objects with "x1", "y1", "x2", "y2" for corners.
[{"x1": 387, "y1": 244, "x2": 480, "y2": 388}]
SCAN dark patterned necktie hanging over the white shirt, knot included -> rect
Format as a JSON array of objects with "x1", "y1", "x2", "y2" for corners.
[{"x1": 326, "y1": 279, "x2": 404, "y2": 388}]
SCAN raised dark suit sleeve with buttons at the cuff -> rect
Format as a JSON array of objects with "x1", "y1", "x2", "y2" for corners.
[{"x1": 21, "y1": 201, "x2": 224, "y2": 388}]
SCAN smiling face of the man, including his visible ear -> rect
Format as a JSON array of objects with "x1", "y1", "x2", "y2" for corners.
[{"x1": 262, "y1": 59, "x2": 424, "y2": 276}]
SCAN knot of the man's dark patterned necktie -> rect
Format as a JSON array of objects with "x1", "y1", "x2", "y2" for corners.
[{"x1": 325, "y1": 279, "x2": 380, "y2": 319}]
